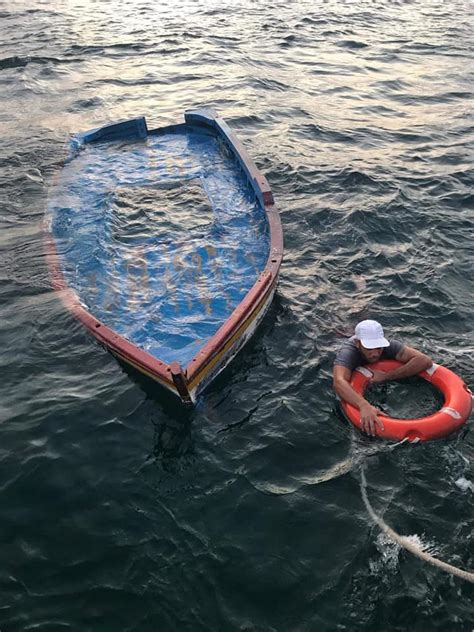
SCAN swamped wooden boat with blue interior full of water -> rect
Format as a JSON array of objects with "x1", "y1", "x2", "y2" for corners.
[{"x1": 46, "y1": 109, "x2": 283, "y2": 403}]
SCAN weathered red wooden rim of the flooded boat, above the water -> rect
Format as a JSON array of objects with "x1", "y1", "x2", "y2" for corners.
[{"x1": 45, "y1": 109, "x2": 283, "y2": 400}]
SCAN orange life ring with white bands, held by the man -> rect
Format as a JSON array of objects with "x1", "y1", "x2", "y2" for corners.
[{"x1": 341, "y1": 360, "x2": 473, "y2": 441}]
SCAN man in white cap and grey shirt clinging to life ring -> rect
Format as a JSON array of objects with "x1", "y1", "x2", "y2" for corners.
[{"x1": 333, "y1": 320, "x2": 433, "y2": 435}]
